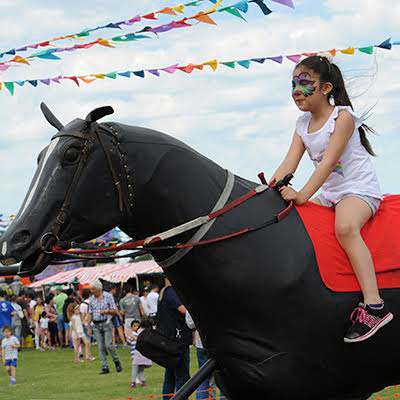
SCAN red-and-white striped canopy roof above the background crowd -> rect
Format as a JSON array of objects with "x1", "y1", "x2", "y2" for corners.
[{"x1": 29, "y1": 261, "x2": 162, "y2": 288}]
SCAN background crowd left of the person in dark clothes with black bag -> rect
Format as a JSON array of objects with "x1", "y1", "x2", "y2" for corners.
[{"x1": 0, "y1": 281, "x2": 159, "y2": 387}]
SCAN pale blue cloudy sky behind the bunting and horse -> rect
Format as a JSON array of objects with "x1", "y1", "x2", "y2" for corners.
[{"x1": 0, "y1": 0, "x2": 400, "y2": 215}]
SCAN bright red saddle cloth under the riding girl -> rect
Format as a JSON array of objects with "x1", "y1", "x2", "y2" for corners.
[{"x1": 296, "y1": 195, "x2": 400, "y2": 292}]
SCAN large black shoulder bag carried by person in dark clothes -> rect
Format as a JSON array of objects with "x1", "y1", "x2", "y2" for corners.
[{"x1": 136, "y1": 328, "x2": 188, "y2": 368}]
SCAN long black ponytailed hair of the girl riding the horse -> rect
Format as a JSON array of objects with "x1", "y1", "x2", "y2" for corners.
[{"x1": 296, "y1": 56, "x2": 376, "y2": 156}]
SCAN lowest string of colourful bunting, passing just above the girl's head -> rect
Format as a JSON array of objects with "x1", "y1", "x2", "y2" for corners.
[{"x1": 0, "y1": 38, "x2": 394, "y2": 95}]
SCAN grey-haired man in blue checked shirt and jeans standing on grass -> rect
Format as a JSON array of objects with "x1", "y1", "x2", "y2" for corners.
[{"x1": 88, "y1": 280, "x2": 122, "y2": 374}]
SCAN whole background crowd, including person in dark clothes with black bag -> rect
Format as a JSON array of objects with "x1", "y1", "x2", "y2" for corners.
[{"x1": 0, "y1": 278, "x2": 222, "y2": 399}]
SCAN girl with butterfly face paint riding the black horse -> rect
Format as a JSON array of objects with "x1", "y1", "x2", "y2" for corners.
[{"x1": 270, "y1": 56, "x2": 393, "y2": 343}]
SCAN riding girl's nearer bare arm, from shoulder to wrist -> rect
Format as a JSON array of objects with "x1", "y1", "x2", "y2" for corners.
[{"x1": 299, "y1": 111, "x2": 354, "y2": 202}]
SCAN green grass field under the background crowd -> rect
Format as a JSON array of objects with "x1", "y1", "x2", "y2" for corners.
[{"x1": 0, "y1": 347, "x2": 400, "y2": 400}]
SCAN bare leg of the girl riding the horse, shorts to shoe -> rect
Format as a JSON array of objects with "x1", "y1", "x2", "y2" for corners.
[{"x1": 335, "y1": 197, "x2": 382, "y2": 304}]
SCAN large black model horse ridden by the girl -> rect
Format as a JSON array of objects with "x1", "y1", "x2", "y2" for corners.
[{"x1": 0, "y1": 106, "x2": 400, "y2": 400}]
